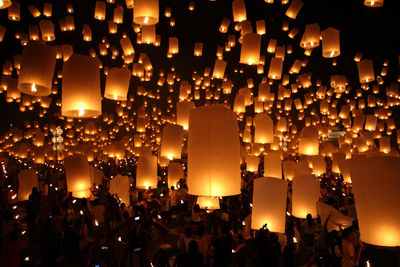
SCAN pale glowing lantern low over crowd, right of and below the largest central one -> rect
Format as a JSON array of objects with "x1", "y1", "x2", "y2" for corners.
[{"x1": 251, "y1": 178, "x2": 288, "y2": 233}]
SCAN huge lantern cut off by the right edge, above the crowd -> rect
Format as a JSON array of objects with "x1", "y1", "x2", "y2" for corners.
[{"x1": 350, "y1": 157, "x2": 400, "y2": 247}]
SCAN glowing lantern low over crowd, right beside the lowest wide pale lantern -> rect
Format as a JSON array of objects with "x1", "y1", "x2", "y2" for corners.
[{"x1": 292, "y1": 174, "x2": 320, "y2": 219}]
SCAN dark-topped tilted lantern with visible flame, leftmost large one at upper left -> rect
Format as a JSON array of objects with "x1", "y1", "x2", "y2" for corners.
[{"x1": 18, "y1": 42, "x2": 57, "y2": 96}]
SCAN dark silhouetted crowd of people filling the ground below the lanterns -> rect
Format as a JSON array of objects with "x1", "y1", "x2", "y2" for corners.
[{"x1": 0, "y1": 159, "x2": 399, "y2": 267}]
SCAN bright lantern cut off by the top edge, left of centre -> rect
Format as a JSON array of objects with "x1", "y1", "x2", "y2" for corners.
[{"x1": 133, "y1": 0, "x2": 160, "y2": 25}]
